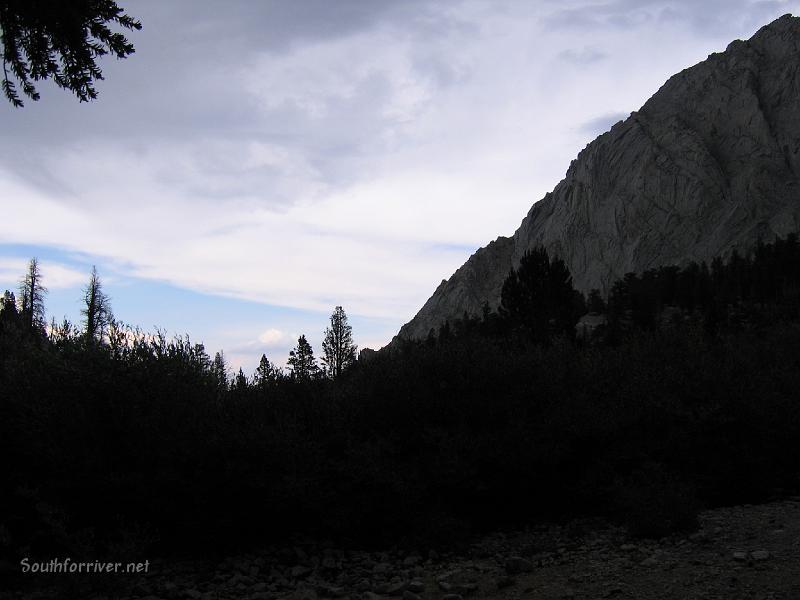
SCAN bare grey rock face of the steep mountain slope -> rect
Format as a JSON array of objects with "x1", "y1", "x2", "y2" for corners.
[{"x1": 399, "y1": 15, "x2": 800, "y2": 339}]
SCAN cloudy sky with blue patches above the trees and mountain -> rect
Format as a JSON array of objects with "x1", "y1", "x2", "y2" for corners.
[{"x1": 0, "y1": 0, "x2": 800, "y2": 373}]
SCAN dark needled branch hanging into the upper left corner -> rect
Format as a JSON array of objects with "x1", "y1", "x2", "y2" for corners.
[{"x1": 0, "y1": 0, "x2": 142, "y2": 108}]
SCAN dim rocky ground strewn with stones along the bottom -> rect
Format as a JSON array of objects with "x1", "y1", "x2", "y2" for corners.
[{"x1": 6, "y1": 498, "x2": 800, "y2": 600}]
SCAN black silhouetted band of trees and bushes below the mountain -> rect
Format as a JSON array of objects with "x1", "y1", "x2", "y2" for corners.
[{"x1": 0, "y1": 236, "x2": 800, "y2": 557}]
